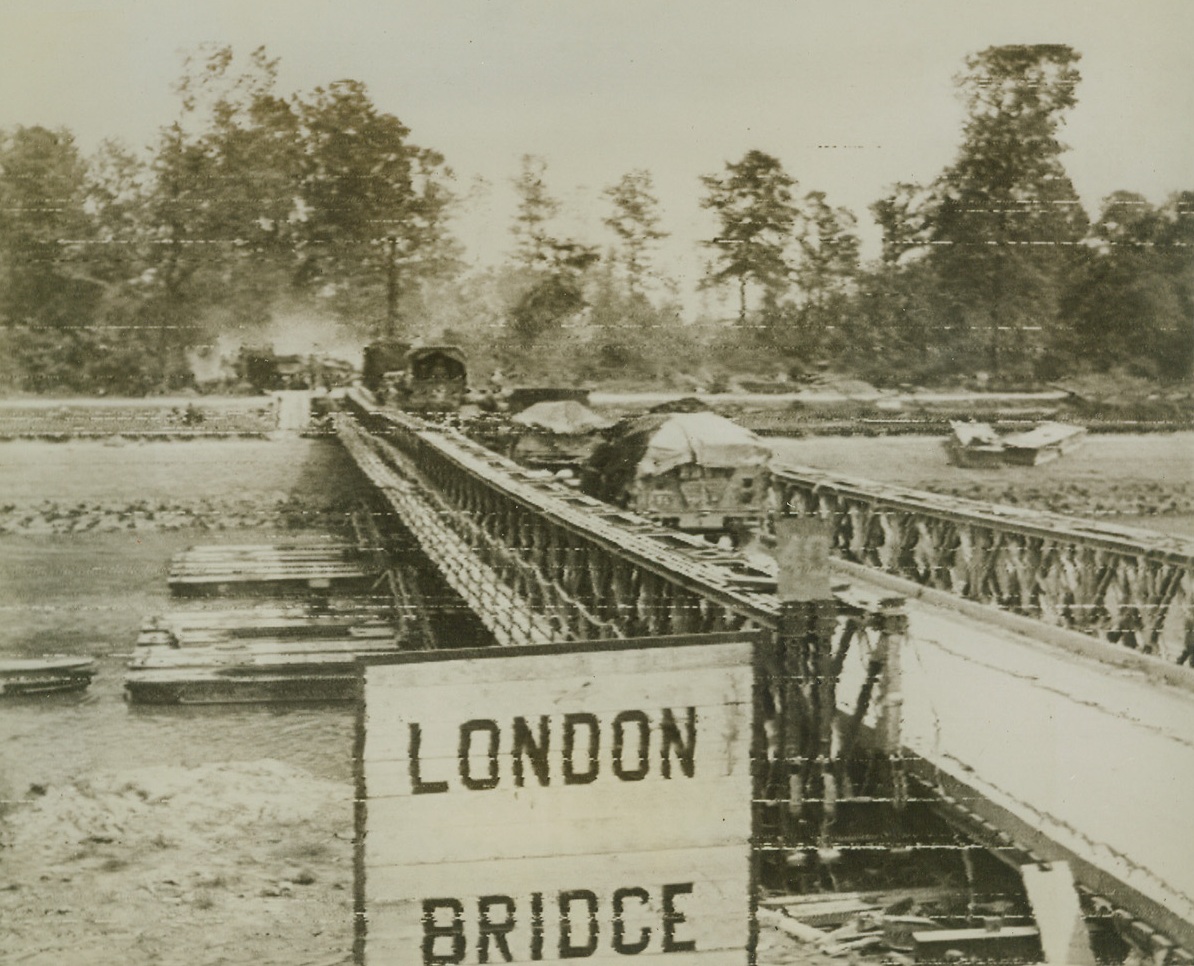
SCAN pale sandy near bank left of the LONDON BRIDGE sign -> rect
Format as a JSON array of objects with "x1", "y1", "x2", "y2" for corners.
[{"x1": 0, "y1": 759, "x2": 352, "y2": 966}]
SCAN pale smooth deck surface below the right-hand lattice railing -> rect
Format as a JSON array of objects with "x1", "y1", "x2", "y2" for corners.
[{"x1": 843, "y1": 572, "x2": 1194, "y2": 943}]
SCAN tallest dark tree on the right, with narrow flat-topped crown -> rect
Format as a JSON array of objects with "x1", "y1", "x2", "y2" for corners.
[{"x1": 925, "y1": 44, "x2": 1088, "y2": 373}]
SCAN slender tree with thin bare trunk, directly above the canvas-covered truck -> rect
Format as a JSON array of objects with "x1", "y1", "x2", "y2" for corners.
[{"x1": 701, "y1": 150, "x2": 799, "y2": 325}]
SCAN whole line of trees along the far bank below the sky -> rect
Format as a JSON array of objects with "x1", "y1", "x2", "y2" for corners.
[{"x1": 0, "y1": 45, "x2": 1194, "y2": 393}]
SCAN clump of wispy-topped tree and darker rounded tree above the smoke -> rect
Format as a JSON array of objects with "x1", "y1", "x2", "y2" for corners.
[{"x1": 139, "y1": 47, "x2": 454, "y2": 341}]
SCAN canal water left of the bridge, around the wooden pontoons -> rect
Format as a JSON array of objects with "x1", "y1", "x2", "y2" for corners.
[{"x1": 0, "y1": 529, "x2": 352, "y2": 799}]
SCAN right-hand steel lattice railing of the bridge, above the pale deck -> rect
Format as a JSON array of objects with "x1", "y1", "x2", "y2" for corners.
[{"x1": 769, "y1": 464, "x2": 1194, "y2": 664}]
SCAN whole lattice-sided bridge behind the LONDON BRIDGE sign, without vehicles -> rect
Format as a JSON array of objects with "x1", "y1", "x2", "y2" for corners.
[{"x1": 336, "y1": 394, "x2": 1194, "y2": 962}]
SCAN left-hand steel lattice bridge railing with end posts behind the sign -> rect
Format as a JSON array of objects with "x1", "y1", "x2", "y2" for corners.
[{"x1": 337, "y1": 400, "x2": 906, "y2": 848}]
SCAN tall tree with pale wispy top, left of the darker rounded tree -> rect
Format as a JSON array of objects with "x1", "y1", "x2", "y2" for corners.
[{"x1": 144, "y1": 47, "x2": 301, "y2": 343}]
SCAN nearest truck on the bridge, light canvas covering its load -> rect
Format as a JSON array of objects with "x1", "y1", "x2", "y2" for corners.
[{"x1": 580, "y1": 412, "x2": 771, "y2": 534}]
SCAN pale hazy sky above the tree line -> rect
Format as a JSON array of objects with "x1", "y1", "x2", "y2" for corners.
[{"x1": 0, "y1": 0, "x2": 1194, "y2": 308}]
